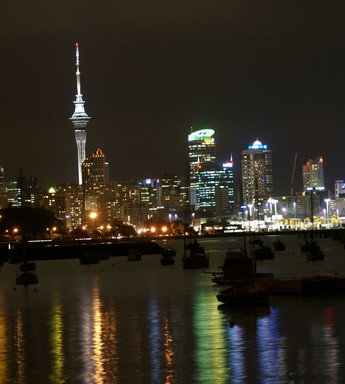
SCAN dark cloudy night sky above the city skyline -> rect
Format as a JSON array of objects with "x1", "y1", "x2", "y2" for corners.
[{"x1": 0, "y1": 0, "x2": 345, "y2": 194}]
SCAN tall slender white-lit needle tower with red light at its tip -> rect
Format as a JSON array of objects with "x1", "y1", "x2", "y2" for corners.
[{"x1": 70, "y1": 43, "x2": 91, "y2": 184}]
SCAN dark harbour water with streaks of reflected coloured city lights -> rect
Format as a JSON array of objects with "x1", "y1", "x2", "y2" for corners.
[{"x1": 0, "y1": 236, "x2": 345, "y2": 384}]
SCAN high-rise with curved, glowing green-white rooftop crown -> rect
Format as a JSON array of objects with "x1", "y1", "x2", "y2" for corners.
[{"x1": 188, "y1": 129, "x2": 216, "y2": 207}]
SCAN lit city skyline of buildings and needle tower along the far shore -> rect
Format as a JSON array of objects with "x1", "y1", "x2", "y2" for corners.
[{"x1": 0, "y1": 44, "x2": 345, "y2": 229}]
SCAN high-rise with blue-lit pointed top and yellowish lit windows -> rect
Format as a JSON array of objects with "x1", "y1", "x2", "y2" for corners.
[{"x1": 242, "y1": 140, "x2": 273, "y2": 208}]
